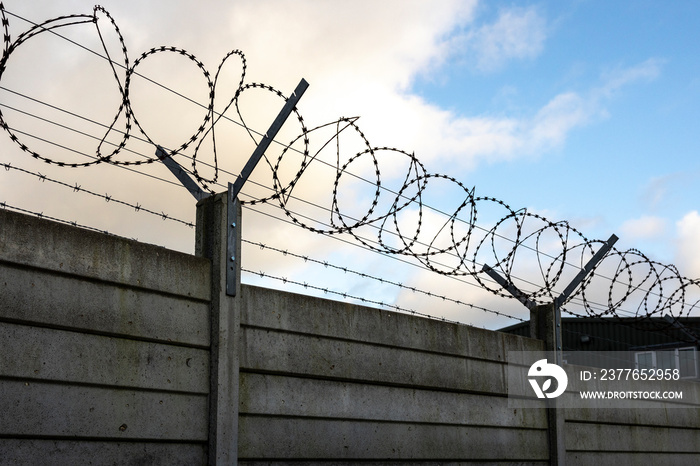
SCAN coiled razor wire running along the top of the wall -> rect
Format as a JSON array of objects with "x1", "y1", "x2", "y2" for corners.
[{"x1": 0, "y1": 4, "x2": 700, "y2": 332}]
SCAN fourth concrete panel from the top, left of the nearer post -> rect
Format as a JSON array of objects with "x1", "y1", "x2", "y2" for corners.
[{"x1": 0, "y1": 380, "x2": 208, "y2": 442}]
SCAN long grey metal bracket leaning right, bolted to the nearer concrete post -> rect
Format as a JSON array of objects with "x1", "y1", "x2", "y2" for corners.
[{"x1": 227, "y1": 79, "x2": 309, "y2": 296}]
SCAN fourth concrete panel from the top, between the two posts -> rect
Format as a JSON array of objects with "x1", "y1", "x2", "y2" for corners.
[{"x1": 238, "y1": 415, "x2": 547, "y2": 461}]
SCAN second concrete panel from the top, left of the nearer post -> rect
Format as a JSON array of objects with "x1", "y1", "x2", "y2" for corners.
[{"x1": 0, "y1": 266, "x2": 209, "y2": 347}]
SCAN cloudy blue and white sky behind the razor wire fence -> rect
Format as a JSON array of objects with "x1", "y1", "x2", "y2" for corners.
[{"x1": 0, "y1": 0, "x2": 700, "y2": 328}]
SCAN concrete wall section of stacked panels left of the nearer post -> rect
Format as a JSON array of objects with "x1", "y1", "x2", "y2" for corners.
[{"x1": 0, "y1": 210, "x2": 210, "y2": 465}]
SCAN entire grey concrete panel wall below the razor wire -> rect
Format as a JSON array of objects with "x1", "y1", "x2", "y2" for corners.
[{"x1": 0, "y1": 203, "x2": 700, "y2": 465}]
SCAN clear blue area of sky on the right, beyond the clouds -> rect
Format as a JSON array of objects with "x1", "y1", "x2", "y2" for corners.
[{"x1": 411, "y1": 2, "x2": 700, "y2": 261}]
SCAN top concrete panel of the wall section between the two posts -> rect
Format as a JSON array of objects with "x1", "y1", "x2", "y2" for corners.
[{"x1": 241, "y1": 286, "x2": 542, "y2": 361}]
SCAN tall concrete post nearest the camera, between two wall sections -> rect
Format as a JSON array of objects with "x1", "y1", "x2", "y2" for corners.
[{"x1": 195, "y1": 193, "x2": 241, "y2": 466}]
